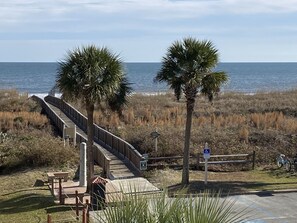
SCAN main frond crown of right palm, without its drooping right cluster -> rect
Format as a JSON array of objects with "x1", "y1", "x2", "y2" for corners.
[{"x1": 154, "y1": 37, "x2": 222, "y2": 99}]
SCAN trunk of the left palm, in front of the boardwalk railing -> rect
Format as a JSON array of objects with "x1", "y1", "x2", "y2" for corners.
[{"x1": 86, "y1": 102, "x2": 94, "y2": 192}]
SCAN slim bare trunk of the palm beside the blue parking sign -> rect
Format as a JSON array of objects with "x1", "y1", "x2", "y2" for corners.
[{"x1": 182, "y1": 99, "x2": 195, "y2": 185}]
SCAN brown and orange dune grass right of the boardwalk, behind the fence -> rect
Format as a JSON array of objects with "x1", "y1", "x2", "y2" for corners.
[{"x1": 71, "y1": 90, "x2": 297, "y2": 165}]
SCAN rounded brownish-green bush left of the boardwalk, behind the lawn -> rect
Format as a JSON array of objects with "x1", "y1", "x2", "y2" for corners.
[{"x1": 0, "y1": 130, "x2": 79, "y2": 171}]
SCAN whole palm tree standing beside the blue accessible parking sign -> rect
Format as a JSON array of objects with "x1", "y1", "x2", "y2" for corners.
[{"x1": 155, "y1": 38, "x2": 227, "y2": 185}]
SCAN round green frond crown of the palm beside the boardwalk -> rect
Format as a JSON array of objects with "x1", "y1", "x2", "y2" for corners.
[{"x1": 56, "y1": 45, "x2": 131, "y2": 104}]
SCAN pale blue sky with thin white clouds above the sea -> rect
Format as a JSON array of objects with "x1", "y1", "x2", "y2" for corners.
[{"x1": 0, "y1": 0, "x2": 297, "y2": 62}]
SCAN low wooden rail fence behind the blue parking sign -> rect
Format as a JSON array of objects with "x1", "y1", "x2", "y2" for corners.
[{"x1": 147, "y1": 151, "x2": 256, "y2": 169}]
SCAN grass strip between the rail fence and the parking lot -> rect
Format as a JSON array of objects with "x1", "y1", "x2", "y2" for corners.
[{"x1": 147, "y1": 168, "x2": 297, "y2": 193}]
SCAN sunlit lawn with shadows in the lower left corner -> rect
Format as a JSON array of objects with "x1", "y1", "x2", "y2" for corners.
[{"x1": 0, "y1": 170, "x2": 77, "y2": 223}]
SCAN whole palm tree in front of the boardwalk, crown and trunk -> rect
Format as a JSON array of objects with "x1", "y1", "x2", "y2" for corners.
[{"x1": 56, "y1": 45, "x2": 131, "y2": 191}]
